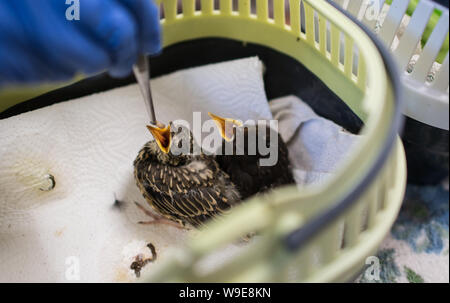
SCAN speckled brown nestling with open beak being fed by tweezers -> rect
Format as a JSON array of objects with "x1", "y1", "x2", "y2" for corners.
[{"x1": 134, "y1": 124, "x2": 241, "y2": 226}]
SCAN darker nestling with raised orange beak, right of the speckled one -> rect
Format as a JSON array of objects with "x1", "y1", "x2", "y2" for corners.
[{"x1": 208, "y1": 113, "x2": 295, "y2": 199}]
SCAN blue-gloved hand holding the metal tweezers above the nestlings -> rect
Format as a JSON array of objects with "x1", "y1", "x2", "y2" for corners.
[{"x1": 0, "y1": 0, "x2": 161, "y2": 85}]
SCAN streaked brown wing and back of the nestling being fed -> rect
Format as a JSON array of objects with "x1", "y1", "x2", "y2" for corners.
[{"x1": 138, "y1": 155, "x2": 240, "y2": 225}]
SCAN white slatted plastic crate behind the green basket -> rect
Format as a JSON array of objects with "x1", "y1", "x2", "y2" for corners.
[{"x1": 334, "y1": 0, "x2": 449, "y2": 130}]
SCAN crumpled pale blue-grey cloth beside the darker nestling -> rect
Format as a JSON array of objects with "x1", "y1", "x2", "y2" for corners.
[{"x1": 269, "y1": 96, "x2": 358, "y2": 185}]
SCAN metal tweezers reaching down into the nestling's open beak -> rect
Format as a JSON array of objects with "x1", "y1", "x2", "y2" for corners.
[{"x1": 133, "y1": 55, "x2": 158, "y2": 125}]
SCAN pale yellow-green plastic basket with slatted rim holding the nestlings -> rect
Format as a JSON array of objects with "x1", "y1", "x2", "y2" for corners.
[{"x1": 0, "y1": 0, "x2": 406, "y2": 282}]
